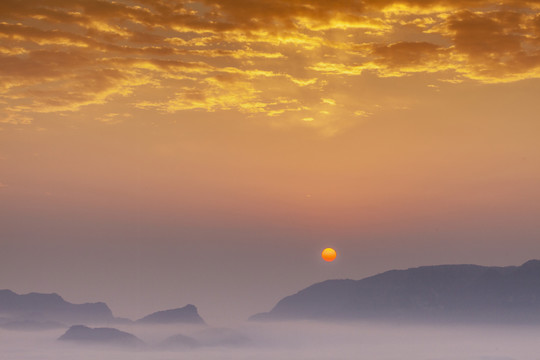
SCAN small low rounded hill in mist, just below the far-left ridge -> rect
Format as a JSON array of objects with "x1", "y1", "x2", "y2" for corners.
[{"x1": 58, "y1": 325, "x2": 144, "y2": 347}]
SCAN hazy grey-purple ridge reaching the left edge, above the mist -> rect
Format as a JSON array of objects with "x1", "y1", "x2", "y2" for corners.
[{"x1": 0, "y1": 290, "x2": 114, "y2": 324}]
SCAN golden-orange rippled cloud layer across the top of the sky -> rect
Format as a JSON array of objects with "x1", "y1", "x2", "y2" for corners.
[{"x1": 0, "y1": 0, "x2": 540, "y2": 126}]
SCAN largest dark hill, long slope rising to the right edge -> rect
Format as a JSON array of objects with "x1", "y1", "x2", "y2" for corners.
[{"x1": 250, "y1": 260, "x2": 540, "y2": 322}]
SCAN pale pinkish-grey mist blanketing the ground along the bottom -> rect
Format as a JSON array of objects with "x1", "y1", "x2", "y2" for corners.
[{"x1": 0, "y1": 321, "x2": 540, "y2": 360}]
